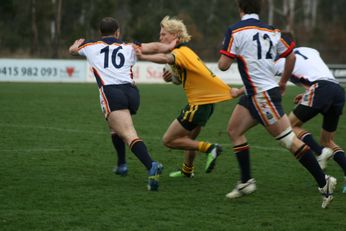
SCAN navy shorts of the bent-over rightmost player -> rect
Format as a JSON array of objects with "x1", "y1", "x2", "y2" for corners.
[{"x1": 293, "y1": 80, "x2": 345, "y2": 132}]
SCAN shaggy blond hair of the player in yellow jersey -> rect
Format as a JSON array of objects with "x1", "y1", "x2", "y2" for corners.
[{"x1": 161, "y1": 16, "x2": 191, "y2": 43}]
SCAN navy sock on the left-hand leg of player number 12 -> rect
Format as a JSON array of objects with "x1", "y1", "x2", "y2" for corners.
[{"x1": 233, "y1": 143, "x2": 251, "y2": 183}]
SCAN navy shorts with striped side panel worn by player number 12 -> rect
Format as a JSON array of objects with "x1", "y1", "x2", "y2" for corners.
[{"x1": 238, "y1": 87, "x2": 285, "y2": 126}]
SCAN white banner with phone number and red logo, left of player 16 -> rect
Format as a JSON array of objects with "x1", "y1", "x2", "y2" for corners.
[{"x1": 0, "y1": 59, "x2": 87, "y2": 82}]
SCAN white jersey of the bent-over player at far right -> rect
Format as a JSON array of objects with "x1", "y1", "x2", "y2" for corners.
[{"x1": 275, "y1": 47, "x2": 337, "y2": 86}]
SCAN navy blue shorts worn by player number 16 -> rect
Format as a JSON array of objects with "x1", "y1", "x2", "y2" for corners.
[{"x1": 100, "y1": 84, "x2": 140, "y2": 118}]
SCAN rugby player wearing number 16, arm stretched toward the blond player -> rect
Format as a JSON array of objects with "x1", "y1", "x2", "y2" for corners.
[{"x1": 69, "y1": 17, "x2": 175, "y2": 191}]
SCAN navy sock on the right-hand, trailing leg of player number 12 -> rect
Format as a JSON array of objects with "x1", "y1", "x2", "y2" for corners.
[{"x1": 294, "y1": 145, "x2": 326, "y2": 188}]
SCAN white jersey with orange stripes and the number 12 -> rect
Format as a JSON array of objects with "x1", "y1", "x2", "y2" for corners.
[{"x1": 220, "y1": 14, "x2": 295, "y2": 95}]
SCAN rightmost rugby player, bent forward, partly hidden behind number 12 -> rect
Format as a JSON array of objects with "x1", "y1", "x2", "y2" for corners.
[{"x1": 275, "y1": 32, "x2": 346, "y2": 193}]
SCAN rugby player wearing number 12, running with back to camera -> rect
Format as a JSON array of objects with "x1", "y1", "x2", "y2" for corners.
[{"x1": 218, "y1": 0, "x2": 336, "y2": 208}]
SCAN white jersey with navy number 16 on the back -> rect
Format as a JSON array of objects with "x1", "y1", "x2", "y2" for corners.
[{"x1": 78, "y1": 37, "x2": 137, "y2": 87}]
